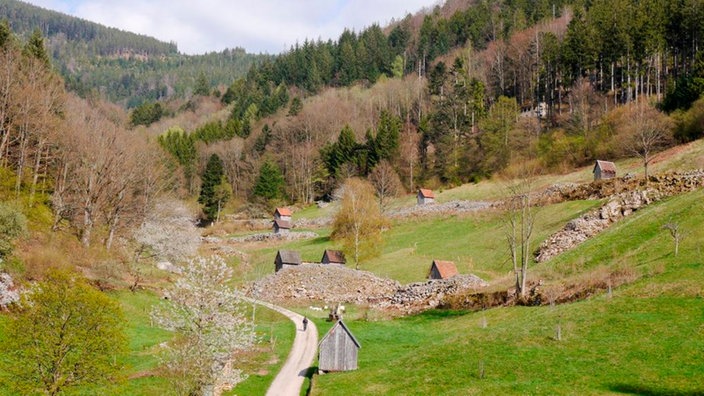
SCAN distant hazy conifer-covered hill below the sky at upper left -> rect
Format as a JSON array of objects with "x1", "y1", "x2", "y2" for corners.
[{"x1": 0, "y1": 0, "x2": 265, "y2": 107}]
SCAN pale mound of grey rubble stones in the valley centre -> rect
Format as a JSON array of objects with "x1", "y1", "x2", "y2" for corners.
[{"x1": 247, "y1": 264, "x2": 487, "y2": 314}]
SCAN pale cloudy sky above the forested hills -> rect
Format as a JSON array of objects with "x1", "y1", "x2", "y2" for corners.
[{"x1": 24, "y1": 0, "x2": 438, "y2": 54}]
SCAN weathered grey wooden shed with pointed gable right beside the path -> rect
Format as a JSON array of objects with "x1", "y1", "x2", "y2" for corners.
[{"x1": 318, "y1": 320, "x2": 362, "y2": 372}]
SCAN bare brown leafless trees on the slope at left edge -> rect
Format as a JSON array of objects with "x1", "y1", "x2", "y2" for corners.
[{"x1": 0, "y1": 23, "x2": 170, "y2": 254}]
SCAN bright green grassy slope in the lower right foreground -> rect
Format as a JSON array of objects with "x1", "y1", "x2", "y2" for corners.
[{"x1": 313, "y1": 191, "x2": 704, "y2": 395}]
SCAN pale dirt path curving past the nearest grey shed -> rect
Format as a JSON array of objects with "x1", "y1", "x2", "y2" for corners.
[{"x1": 247, "y1": 299, "x2": 318, "y2": 396}]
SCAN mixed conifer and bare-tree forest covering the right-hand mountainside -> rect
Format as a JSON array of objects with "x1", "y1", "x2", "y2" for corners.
[{"x1": 164, "y1": 0, "x2": 704, "y2": 202}]
